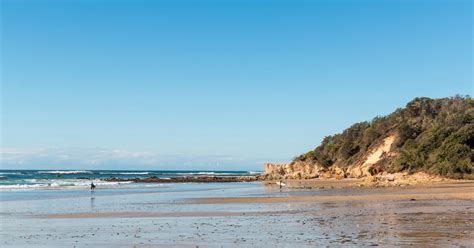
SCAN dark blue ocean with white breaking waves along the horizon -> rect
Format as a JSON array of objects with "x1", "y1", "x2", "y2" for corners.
[{"x1": 0, "y1": 170, "x2": 261, "y2": 191}]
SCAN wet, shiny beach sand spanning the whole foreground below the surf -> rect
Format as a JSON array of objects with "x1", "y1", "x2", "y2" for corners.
[{"x1": 0, "y1": 181, "x2": 474, "y2": 247}]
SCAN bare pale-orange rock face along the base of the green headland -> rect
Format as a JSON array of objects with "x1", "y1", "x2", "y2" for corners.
[{"x1": 263, "y1": 135, "x2": 396, "y2": 180}]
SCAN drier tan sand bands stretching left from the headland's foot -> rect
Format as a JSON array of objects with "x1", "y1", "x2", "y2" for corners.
[{"x1": 35, "y1": 179, "x2": 474, "y2": 219}]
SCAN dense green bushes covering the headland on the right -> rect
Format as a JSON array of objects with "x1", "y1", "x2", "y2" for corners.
[{"x1": 293, "y1": 96, "x2": 474, "y2": 178}]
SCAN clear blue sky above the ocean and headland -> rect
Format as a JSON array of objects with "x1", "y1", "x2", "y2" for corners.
[{"x1": 1, "y1": 0, "x2": 473, "y2": 170}]
